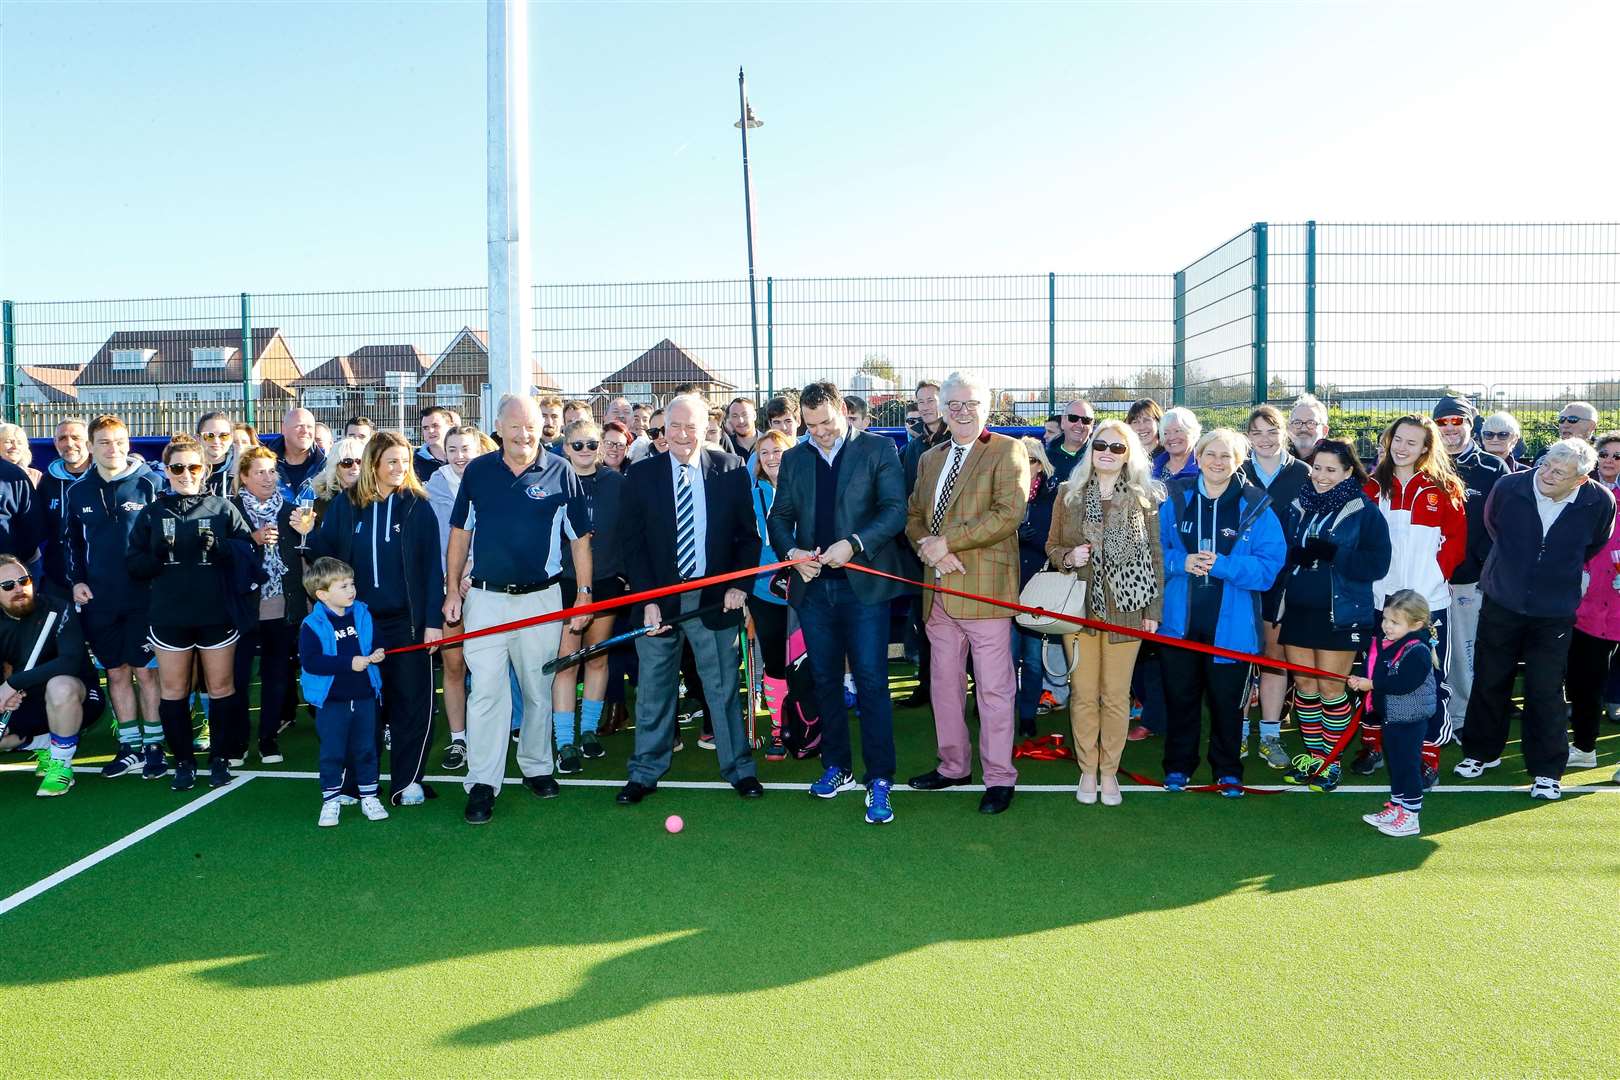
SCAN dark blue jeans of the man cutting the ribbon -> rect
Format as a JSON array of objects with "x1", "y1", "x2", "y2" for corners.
[{"x1": 799, "y1": 576, "x2": 894, "y2": 784}]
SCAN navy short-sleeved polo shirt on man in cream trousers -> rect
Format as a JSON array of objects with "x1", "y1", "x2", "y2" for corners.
[{"x1": 450, "y1": 452, "x2": 591, "y2": 585}]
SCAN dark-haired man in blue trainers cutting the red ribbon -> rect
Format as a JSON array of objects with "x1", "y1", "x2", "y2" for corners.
[{"x1": 766, "y1": 382, "x2": 910, "y2": 824}]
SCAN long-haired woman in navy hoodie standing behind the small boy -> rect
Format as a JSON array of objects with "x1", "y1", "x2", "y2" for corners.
[{"x1": 309, "y1": 431, "x2": 444, "y2": 806}]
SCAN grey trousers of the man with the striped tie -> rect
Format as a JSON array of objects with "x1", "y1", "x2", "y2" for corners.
[{"x1": 630, "y1": 589, "x2": 755, "y2": 787}]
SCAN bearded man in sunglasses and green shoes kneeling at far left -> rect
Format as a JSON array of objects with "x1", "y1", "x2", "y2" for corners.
[{"x1": 0, "y1": 555, "x2": 104, "y2": 798}]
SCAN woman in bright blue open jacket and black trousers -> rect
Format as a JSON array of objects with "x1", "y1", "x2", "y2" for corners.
[{"x1": 1158, "y1": 427, "x2": 1288, "y2": 798}]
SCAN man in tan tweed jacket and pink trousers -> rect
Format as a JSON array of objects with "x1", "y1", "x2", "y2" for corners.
[{"x1": 906, "y1": 372, "x2": 1029, "y2": 814}]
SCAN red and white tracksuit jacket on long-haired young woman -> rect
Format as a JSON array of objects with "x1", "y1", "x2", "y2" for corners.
[{"x1": 1366, "y1": 473, "x2": 1468, "y2": 610}]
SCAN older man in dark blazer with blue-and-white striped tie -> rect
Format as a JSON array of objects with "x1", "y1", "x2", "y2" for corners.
[{"x1": 617, "y1": 393, "x2": 765, "y2": 806}]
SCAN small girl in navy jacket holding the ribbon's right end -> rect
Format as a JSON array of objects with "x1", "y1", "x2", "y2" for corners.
[{"x1": 1345, "y1": 589, "x2": 1435, "y2": 836}]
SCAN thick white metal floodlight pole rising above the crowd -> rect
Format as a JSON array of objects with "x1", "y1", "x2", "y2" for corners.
[{"x1": 484, "y1": 0, "x2": 535, "y2": 426}]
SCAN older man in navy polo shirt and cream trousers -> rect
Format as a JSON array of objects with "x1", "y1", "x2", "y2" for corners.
[{"x1": 444, "y1": 393, "x2": 591, "y2": 824}]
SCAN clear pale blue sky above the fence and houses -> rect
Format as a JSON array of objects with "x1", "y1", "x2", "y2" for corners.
[{"x1": 0, "y1": 0, "x2": 1620, "y2": 300}]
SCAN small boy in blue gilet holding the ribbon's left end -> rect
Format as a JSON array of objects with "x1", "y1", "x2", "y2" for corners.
[{"x1": 298, "y1": 559, "x2": 389, "y2": 826}]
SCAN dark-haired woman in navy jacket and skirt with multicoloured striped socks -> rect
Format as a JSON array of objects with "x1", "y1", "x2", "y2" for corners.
[{"x1": 1278, "y1": 439, "x2": 1390, "y2": 792}]
